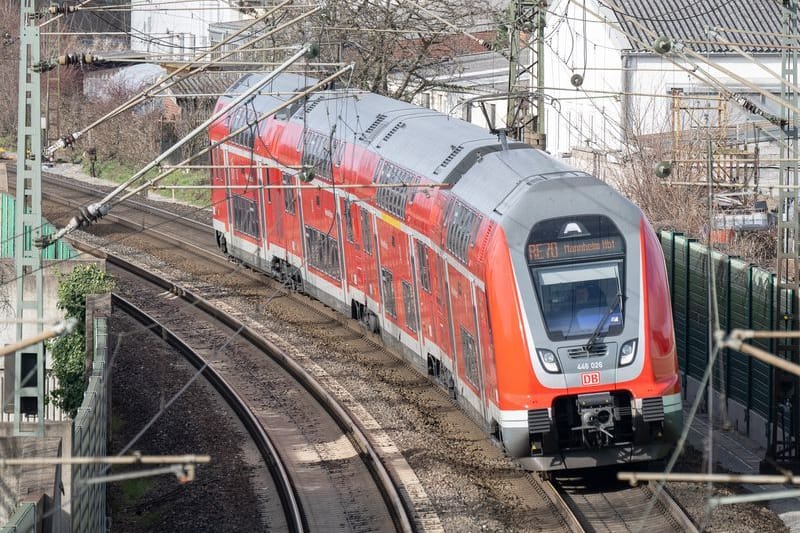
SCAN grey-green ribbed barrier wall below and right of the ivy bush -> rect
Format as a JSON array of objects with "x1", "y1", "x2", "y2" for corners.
[{"x1": 72, "y1": 318, "x2": 109, "y2": 533}]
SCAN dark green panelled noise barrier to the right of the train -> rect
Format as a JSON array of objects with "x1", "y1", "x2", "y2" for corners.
[{"x1": 660, "y1": 231, "x2": 791, "y2": 422}]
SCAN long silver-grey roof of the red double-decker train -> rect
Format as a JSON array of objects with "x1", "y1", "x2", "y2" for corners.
[{"x1": 222, "y1": 73, "x2": 641, "y2": 229}]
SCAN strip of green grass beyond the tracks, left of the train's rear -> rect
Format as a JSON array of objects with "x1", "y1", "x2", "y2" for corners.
[{"x1": 83, "y1": 160, "x2": 211, "y2": 207}]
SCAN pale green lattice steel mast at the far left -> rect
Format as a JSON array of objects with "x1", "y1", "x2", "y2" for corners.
[{"x1": 13, "y1": 0, "x2": 45, "y2": 436}]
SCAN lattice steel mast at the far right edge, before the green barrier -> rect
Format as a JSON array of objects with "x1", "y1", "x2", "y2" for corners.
[{"x1": 762, "y1": 0, "x2": 800, "y2": 471}]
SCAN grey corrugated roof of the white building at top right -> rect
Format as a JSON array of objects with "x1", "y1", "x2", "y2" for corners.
[{"x1": 599, "y1": 0, "x2": 783, "y2": 53}]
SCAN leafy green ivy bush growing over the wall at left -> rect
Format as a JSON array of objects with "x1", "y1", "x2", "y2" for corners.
[{"x1": 48, "y1": 264, "x2": 114, "y2": 418}]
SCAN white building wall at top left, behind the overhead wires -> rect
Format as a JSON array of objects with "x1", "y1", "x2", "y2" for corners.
[{"x1": 131, "y1": 0, "x2": 245, "y2": 59}]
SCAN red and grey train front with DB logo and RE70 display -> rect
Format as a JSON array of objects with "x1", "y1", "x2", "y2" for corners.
[{"x1": 489, "y1": 173, "x2": 683, "y2": 470}]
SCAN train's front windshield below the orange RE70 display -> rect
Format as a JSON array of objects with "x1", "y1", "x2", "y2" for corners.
[{"x1": 533, "y1": 260, "x2": 624, "y2": 340}]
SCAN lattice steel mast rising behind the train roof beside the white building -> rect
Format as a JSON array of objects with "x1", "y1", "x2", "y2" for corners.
[{"x1": 506, "y1": 0, "x2": 548, "y2": 150}]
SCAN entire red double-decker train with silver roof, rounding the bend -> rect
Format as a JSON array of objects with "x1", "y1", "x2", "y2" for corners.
[{"x1": 210, "y1": 74, "x2": 683, "y2": 471}]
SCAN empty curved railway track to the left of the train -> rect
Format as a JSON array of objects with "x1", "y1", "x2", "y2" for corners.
[{"x1": 106, "y1": 251, "x2": 412, "y2": 531}]
